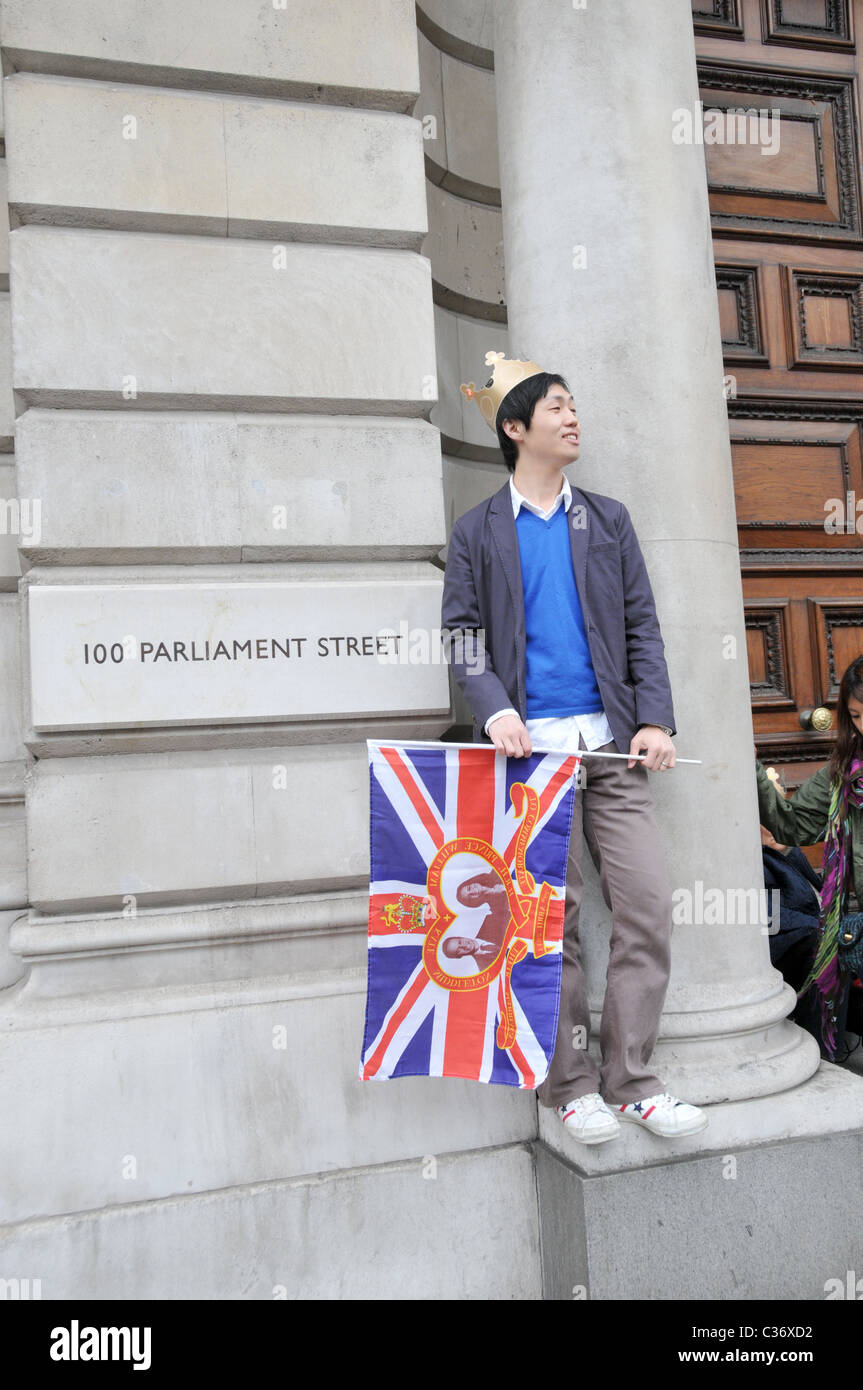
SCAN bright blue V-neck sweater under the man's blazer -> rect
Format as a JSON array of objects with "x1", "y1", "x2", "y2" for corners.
[{"x1": 516, "y1": 506, "x2": 603, "y2": 719}]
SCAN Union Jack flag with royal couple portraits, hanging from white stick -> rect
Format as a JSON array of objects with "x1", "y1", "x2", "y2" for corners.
[{"x1": 360, "y1": 741, "x2": 581, "y2": 1088}]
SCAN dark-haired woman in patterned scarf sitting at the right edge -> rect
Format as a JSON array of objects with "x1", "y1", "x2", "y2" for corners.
[{"x1": 756, "y1": 656, "x2": 863, "y2": 1062}]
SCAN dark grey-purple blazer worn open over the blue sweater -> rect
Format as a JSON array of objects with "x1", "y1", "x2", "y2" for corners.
[{"x1": 442, "y1": 481, "x2": 674, "y2": 752}]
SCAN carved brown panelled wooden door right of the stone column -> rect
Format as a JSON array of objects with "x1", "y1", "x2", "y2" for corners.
[{"x1": 692, "y1": 0, "x2": 863, "y2": 790}]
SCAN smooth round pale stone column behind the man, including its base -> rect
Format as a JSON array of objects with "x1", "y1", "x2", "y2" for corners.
[{"x1": 495, "y1": 0, "x2": 863, "y2": 1297}]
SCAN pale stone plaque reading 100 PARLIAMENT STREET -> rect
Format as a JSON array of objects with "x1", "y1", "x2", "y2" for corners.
[{"x1": 29, "y1": 580, "x2": 449, "y2": 731}]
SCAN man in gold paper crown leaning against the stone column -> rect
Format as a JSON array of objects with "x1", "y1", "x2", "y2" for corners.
[{"x1": 442, "y1": 353, "x2": 707, "y2": 1144}]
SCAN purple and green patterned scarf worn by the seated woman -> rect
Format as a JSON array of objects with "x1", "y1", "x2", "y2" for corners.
[{"x1": 798, "y1": 758, "x2": 863, "y2": 1062}]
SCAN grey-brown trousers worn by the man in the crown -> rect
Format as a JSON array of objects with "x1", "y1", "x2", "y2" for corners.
[{"x1": 536, "y1": 738, "x2": 671, "y2": 1106}]
